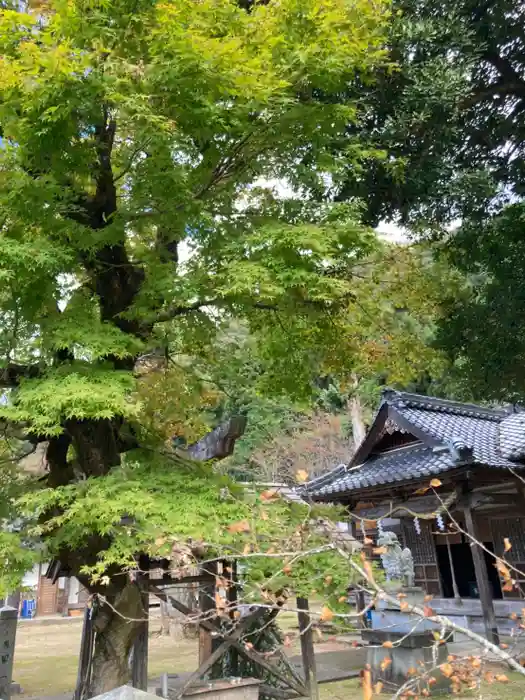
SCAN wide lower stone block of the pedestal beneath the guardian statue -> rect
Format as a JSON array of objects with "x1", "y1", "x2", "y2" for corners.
[{"x1": 361, "y1": 629, "x2": 450, "y2": 695}]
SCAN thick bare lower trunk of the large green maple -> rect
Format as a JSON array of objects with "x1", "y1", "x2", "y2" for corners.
[{"x1": 85, "y1": 582, "x2": 143, "y2": 698}]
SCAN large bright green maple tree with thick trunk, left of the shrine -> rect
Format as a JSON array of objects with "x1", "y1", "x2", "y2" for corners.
[{"x1": 0, "y1": 0, "x2": 388, "y2": 694}]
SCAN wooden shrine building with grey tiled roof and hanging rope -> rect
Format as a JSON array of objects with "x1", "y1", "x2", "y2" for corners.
[{"x1": 306, "y1": 391, "x2": 525, "y2": 642}]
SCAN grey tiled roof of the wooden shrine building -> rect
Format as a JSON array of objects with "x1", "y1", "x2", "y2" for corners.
[{"x1": 306, "y1": 391, "x2": 525, "y2": 498}]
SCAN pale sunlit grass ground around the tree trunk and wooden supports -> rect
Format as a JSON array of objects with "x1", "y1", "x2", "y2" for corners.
[{"x1": 14, "y1": 619, "x2": 525, "y2": 700}]
